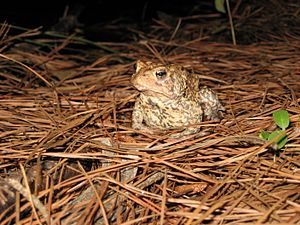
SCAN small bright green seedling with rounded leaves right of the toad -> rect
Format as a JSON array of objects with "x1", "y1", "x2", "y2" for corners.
[{"x1": 259, "y1": 109, "x2": 290, "y2": 150}]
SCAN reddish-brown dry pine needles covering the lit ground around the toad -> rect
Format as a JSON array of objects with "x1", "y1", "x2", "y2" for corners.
[{"x1": 0, "y1": 40, "x2": 300, "y2": 224}]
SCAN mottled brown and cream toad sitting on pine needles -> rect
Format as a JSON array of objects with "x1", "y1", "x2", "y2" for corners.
[{"x1": 131, "y1": 61, "x2": 224, "y2": 138}]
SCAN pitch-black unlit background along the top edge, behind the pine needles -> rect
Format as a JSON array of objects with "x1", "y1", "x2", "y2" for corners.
[{"x1": 0, "y1": 0, "x2": 214, "y2": 28}]
